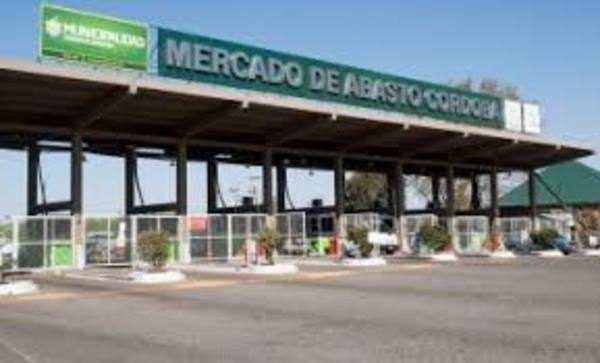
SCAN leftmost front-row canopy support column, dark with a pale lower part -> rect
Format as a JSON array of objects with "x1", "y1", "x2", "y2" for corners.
[{"x1": 71, "y1": 131, "x2": 85, "y2": 268}]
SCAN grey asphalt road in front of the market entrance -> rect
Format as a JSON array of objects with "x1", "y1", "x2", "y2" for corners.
[{"x1": 0, "y1": 258, "x2": 600, "y2": 363}]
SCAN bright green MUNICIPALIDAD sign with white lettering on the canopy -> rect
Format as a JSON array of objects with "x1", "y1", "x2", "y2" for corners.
[{"x1": 40, "y1": 4, "x2": 148, "y2": 70}]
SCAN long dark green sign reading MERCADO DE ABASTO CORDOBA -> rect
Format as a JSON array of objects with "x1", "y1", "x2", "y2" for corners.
[{"x1": 158, "y1": 29, "x2": 503, "y2": 128}]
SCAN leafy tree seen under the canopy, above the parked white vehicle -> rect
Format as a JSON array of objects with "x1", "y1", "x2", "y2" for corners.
[{"x1": 346, "y1": 172, "x2": 388, "y2": 210}]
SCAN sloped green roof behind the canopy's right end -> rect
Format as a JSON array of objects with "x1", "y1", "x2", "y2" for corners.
[{"x1": 499, "y1": 161, "x2": 600, "y2": 207}]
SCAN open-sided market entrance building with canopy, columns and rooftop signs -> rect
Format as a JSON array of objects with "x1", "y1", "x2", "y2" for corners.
[{"x1": 0, "y1": 5, "x2": 594, "y2": 267}]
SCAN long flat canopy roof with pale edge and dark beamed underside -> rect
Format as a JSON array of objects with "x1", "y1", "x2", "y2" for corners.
[{"x1": 0, "y1": 59, "x2": 593, "y2": 169}]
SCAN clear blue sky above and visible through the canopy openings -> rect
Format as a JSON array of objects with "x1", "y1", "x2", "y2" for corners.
[{"x1": 0, "y1": 0, "x2": 600, "y2": 215}]
